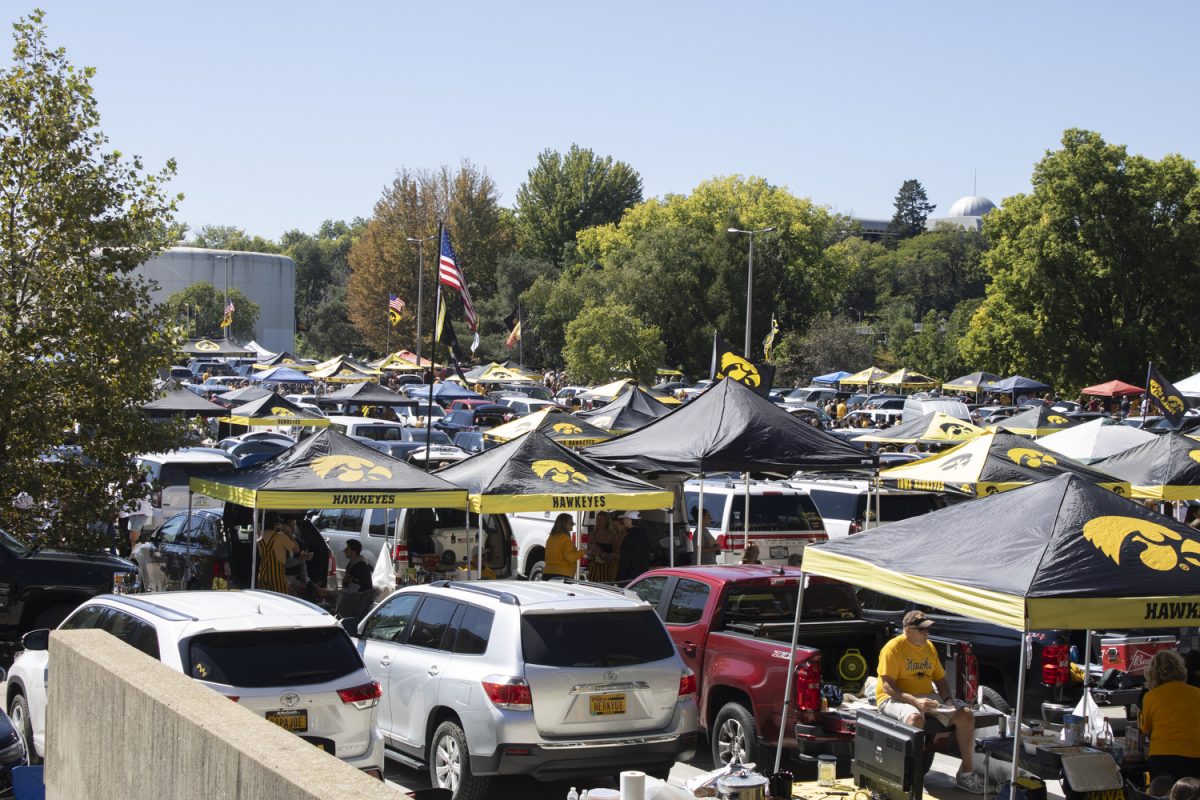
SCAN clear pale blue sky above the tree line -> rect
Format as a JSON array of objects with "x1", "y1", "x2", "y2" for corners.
[{"x1": 18, "y1": 0, "x2": 1200, "y2": 239}]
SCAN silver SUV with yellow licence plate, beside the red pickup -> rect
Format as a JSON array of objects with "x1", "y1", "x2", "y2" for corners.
[{"x1": 359, "y1": 581, "x2": 698, "y2": 800}]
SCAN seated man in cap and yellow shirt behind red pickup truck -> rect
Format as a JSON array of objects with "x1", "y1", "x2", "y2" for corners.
[{"x1": 875, "y1": 610, "x2": 984, "y2": 794}]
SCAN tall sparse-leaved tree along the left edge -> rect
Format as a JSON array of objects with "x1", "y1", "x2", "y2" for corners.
[{"x1": 0, "y1": 11, "x2": 179, "y2": 546}]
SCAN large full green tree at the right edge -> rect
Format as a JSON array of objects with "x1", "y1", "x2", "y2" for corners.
[{"x1": 962, "y1": 130, "x2": 1200, "y2": 386}]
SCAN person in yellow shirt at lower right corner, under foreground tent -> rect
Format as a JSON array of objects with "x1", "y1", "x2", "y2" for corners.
[{"x1": 1138, "y1": 650, "x2": 1200, "y2": 778}]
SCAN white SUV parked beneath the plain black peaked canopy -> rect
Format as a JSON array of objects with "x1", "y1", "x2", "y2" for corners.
[{"x1": 683, "y1": 477, "x2": 829, "y2": 566}]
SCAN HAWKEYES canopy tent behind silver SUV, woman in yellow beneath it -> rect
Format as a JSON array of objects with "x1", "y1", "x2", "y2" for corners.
[{"x1": 437, "y1": 431, "x2": 674, "y2": 582}]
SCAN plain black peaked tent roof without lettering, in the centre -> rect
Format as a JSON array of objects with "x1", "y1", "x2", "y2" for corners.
[{"x1": 582, "y1": 378, "x2": 875, "y2": 475}]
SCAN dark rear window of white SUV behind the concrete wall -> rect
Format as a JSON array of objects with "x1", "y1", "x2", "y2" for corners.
[{"x1": 185, "y1": 627, "x2": 362, "y2": 688}]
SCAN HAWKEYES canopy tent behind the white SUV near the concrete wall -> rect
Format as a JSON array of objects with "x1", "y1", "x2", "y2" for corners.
[{"x1": 188, "y1": 428, "x2": 467, "y2": 585}]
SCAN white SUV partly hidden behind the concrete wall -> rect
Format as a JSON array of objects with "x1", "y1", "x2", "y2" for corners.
[{"x1": 5, "y1": 591, "x2": 383, "y2": 780}]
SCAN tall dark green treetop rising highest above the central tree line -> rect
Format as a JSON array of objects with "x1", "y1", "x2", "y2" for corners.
[{"x1": 516, "y1": 144, "x2": 642, "y2": 264}]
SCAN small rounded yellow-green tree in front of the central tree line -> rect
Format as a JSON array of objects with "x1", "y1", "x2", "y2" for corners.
[{"x1": 563, "y1": 306, "x2": 665, "y2": 384}]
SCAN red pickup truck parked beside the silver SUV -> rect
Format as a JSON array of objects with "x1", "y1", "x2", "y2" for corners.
[{"x1": 629, "y1": 565, "x2": 977, "y2": 764}]
